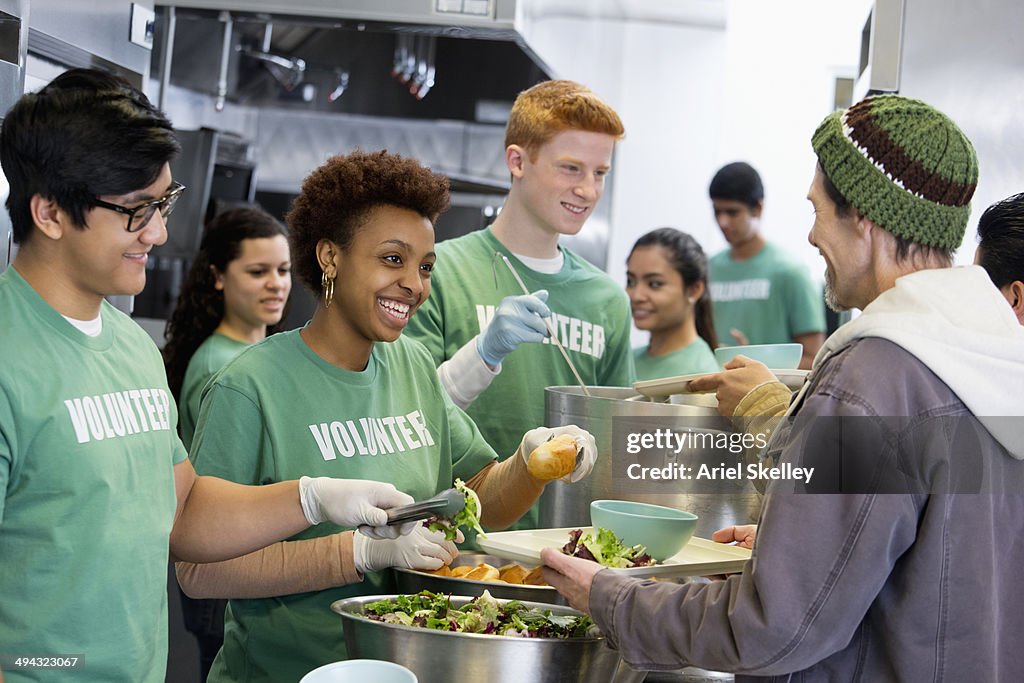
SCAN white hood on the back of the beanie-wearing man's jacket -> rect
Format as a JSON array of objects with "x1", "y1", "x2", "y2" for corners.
[{"x1": 814, "y1": 265, "x2": 1024, "y2": 460}]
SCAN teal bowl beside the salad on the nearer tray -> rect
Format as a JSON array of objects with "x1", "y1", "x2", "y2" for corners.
[{"x1": 590, "y1": 501, "x2": 697, "y2": 562}]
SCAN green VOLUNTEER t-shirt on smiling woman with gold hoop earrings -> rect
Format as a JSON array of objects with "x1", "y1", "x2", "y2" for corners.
[{"x1": 191, "y1": 330, "x2": 496, "y2": 683}]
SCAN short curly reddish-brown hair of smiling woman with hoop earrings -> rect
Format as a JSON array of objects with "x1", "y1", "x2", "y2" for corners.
[{"x1": 285, "y1": 150, "x2": 449, "y2": 297}]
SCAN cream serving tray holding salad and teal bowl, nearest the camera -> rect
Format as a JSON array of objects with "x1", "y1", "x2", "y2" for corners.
[{"x1": 476, "y1": 526, "x2": 751, "y2": 578}]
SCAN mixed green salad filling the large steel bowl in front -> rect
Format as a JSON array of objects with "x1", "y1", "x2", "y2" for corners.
[{"x1": 365, "y1": 591, "x2": 601, "y2": 639}]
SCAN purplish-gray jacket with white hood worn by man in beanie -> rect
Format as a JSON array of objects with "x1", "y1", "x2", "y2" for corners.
[{"x1": 590, "y1": 267, "x2": 1024, "y2": 683}]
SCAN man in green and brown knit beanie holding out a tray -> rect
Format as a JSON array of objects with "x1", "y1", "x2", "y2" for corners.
[{"x1": 542, "y1": 95, "x2": 1024, "y2": 682}]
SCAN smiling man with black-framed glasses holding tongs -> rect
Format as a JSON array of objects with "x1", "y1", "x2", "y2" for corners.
[{"x1": 0, "y1": 70, "x2": 412, "y2": 683}]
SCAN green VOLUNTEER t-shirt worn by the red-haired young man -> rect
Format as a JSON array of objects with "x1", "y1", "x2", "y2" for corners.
[{"x1": 406, "y1": 228, "x2": 634, "y2": 528}]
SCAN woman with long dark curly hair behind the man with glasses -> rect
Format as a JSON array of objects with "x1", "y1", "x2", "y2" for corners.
[{"x1": 164, "y1": 207, "x2": 292, "y2": 681}]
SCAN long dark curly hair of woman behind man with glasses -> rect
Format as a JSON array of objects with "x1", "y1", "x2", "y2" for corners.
[{"x1": 164, "y1": 207, "x2": 287, "y2": 400}]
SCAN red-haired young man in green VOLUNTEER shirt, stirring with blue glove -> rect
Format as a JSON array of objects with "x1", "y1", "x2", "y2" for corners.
[{"x1": 407, "y1": 81, "x2": 634, "y2": 528}]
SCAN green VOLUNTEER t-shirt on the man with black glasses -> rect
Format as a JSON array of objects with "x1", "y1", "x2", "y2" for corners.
[{"x1": 0, "y1": 267, "x2": 185, "y2": 683}]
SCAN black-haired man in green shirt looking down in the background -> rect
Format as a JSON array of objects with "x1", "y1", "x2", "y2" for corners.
[{"x1": 709, "y1": 162, "x2": 825, "y2": 369}]
